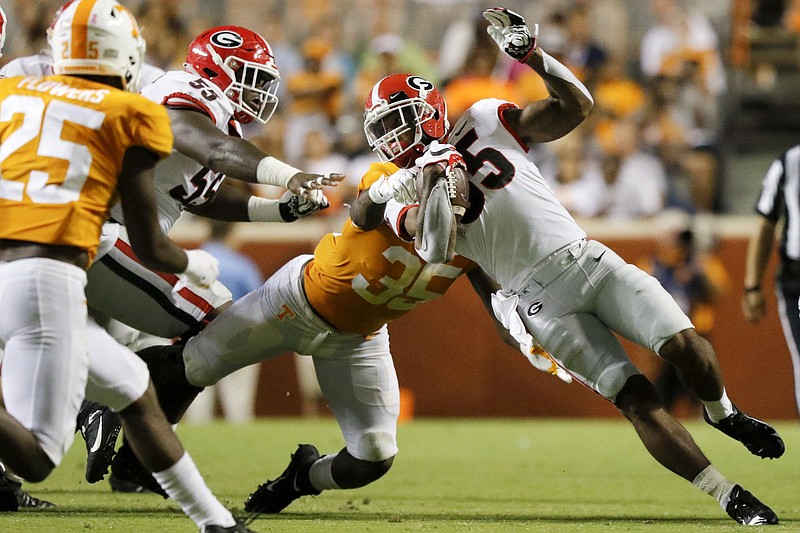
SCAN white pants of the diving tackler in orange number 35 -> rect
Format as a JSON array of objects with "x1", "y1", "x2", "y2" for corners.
[{"x1": 183, "y1": 255, "x2": 400, "y2": 461}]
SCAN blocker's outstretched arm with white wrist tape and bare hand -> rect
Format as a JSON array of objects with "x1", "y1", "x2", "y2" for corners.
[{"x1": 167, "y1": 104, "x2": 344, "y2": 196}]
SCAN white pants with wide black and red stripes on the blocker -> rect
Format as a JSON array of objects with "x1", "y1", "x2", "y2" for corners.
[{"x1": 86, "y1": 222, "x2": 231, "y2": 339}]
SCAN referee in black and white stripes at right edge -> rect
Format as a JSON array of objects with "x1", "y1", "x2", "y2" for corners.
[{"x1": 742, "y1": 145, "x2": 800, "y2": 418}]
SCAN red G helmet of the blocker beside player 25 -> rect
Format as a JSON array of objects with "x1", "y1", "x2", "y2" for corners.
[{"x1": 183, "y1": 26, "x2": 281, "y2": 124}]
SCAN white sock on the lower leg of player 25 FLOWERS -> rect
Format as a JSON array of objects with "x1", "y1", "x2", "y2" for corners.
[{"x1": 153, "y1": 452, "x2": 236, "y2": 529}]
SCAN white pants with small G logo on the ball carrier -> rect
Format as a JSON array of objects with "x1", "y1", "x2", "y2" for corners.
[{"x1": 517, "y1": 240, "x2": 693, "y2": 402}]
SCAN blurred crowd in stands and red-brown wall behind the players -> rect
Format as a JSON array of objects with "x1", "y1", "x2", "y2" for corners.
[{"x1": 0, "y1": 0, "x2": 800, "y2": 418}]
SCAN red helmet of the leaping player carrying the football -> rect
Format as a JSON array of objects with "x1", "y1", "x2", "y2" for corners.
[{"x1": 364, "y1": 74, "x2": 450, "y2": 168}]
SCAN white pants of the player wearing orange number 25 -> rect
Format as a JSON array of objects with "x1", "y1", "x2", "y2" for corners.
[{"x1": 0, "y1": 258, "x2": 149, "y2": 465}]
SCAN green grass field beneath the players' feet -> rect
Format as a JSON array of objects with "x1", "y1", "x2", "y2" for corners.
[{"x1": 0, "y1": 419, "x2": 800, "y2": 533}]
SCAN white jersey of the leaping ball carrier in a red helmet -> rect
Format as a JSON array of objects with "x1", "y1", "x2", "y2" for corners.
[{"x1": 448, "y1": 99, "x2": 586, "y2": 292}]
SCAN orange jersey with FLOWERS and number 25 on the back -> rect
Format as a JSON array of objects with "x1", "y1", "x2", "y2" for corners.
[{"x1": 0, "y1": 76, "x2": 172, "y2": 259}]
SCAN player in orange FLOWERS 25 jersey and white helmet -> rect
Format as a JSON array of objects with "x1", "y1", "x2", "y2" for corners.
[{"x1": 0, "y1": 0, "x2": 248, "y2": 532}]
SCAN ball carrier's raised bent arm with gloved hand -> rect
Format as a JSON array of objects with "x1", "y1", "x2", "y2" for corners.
[{"x1": 483, "y1": 7, "x2": 594, "y2": 143}]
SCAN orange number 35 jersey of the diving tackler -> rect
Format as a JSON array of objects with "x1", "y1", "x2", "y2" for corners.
[{"x1": 304, "y1": 163, "x2": 476, "y2": 335}]
